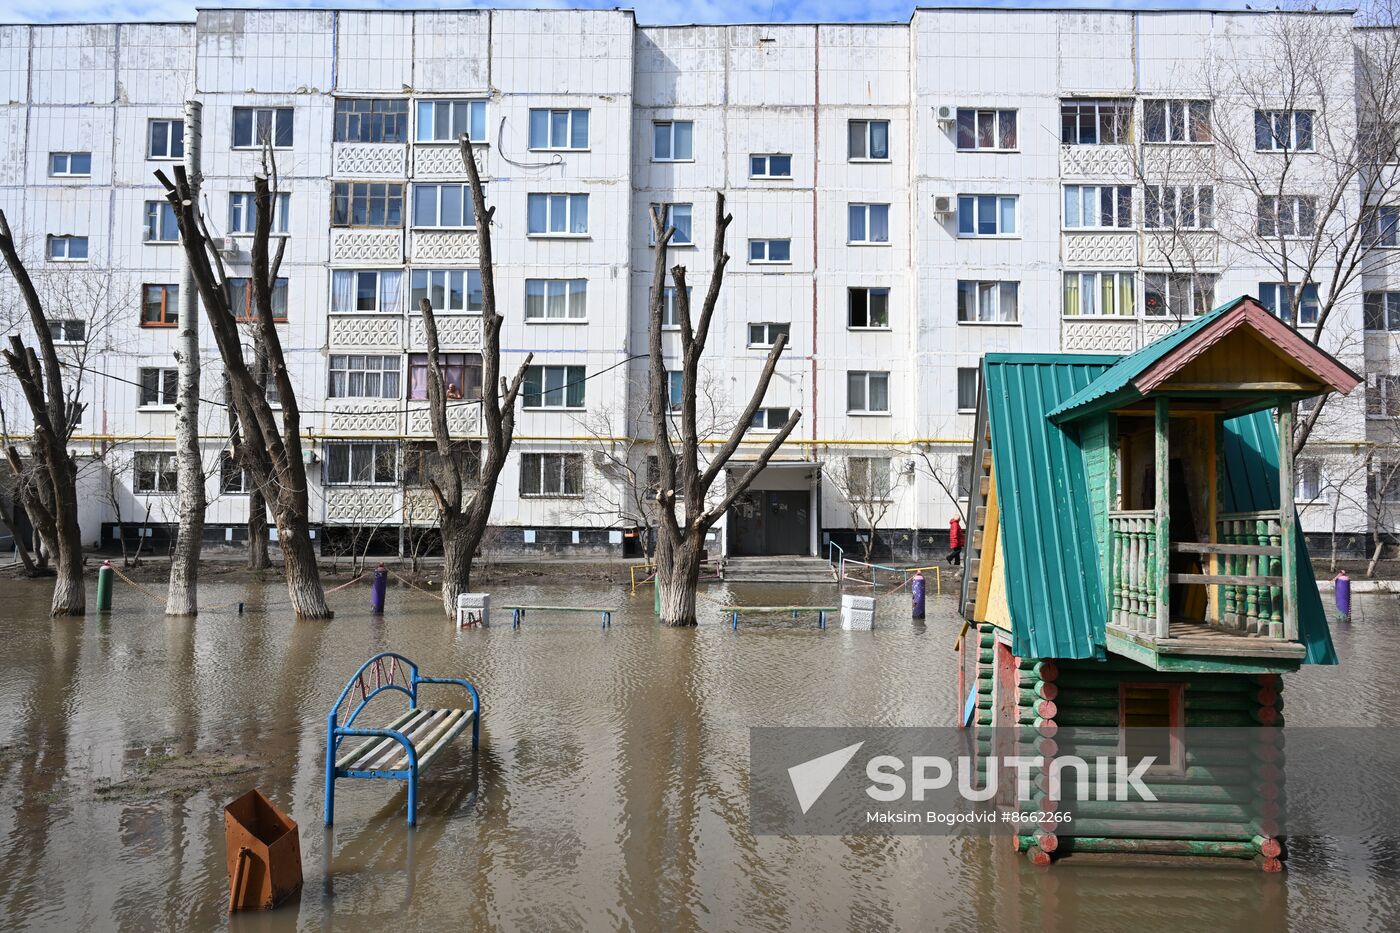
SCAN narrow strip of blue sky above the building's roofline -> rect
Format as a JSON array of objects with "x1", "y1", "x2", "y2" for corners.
[{"x1": 0, "y1": 0, "x2": 1260, "y2": 25}]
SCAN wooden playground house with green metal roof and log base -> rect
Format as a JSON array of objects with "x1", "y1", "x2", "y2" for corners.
[{"x1": 959, "y1": 297, "x2": 1359, "y2": 870}]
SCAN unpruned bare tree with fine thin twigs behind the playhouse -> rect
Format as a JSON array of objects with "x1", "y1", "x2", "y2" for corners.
[{"x1": 1207, "y1": 9, "x2": 1400, "y2": 457}]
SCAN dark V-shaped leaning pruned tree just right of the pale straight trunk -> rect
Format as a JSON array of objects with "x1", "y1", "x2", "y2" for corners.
[{"x1": 155, "y1": 167, "x2": 332, "y2": 619}]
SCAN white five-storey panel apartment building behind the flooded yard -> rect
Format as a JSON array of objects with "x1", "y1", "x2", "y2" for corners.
[{"x1": 0, "y1": 8, "x2": 1383, "y2": 556}]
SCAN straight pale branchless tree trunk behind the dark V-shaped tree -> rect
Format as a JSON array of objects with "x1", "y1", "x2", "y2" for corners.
[{"x1": 165, "y1": 101, "x2": 206, "y2": 615}]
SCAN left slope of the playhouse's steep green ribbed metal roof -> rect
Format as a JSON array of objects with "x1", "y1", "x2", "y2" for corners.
[{"x1": 981, "y1": 353, "x2": 1121, "y2": 657}]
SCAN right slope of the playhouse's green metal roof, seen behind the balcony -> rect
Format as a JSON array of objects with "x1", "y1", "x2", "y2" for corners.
[{"x1": 1224, "y1": 412, "x2": 1337, "y2": 664}]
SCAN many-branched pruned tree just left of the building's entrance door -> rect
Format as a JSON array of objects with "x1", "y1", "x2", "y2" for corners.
[{"x1": 648, "y1": 192, "x2": 802, "y2": 626}]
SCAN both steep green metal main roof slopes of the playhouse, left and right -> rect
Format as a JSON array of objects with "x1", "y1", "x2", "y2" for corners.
[{"x1": 981, "y1": 347, "x2": 1337, "y2": 664}]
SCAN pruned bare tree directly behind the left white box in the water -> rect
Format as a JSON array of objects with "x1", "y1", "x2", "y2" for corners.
[{"x1": 419, "y1": 133, "x2": 533, "y2": 616}]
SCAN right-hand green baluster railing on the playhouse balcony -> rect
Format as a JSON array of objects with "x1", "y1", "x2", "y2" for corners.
[{"x1": 1215, "y1": 510, "x2": 1285, "y2": 639}]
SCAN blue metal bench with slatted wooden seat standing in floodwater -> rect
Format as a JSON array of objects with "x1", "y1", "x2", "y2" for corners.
[{"x1": 325, "y1": 651, "x2": 482, "y2": 827}]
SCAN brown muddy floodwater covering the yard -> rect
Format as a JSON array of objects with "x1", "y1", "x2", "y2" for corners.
[{"x1": 0, "y1": 581, "x2": 1400, "y2": 933}]
